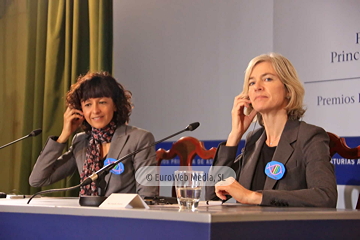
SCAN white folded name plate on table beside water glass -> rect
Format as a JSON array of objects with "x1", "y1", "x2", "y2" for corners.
[{"x1": 99, "y1": 193, "x2": 149, "y2": 209}]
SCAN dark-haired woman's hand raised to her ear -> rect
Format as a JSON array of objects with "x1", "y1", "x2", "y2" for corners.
[{"x1": 57, "y1": 107, "x2": 84, "y2": 143}]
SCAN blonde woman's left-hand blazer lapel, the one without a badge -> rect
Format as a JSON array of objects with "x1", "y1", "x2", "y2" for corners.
[{"x1": 239, "y1": 131, "x2": 266, "y2": 189}]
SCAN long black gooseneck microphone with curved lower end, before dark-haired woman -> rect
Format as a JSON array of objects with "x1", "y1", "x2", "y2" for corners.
[{"x1": 27, "y1": 122, "x2": 200, "y2": 204}]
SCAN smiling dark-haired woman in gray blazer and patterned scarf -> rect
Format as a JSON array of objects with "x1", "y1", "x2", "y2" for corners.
[{"x1": 29, "y1": 72, "x2": 158, "y2": 197}]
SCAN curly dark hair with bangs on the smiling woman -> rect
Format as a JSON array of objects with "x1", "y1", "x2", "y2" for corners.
[{"x1": 66, "y1": 72, "x2": 132, "y2": 132}]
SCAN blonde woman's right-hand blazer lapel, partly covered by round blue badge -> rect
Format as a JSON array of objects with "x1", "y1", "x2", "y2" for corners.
[{"x1": 264, "y1": 120, "x2": 300, "y2": 190}]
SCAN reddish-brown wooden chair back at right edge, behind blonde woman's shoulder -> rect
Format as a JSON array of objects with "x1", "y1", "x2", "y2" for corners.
[{"x1": 327, "y1": 132, "x2": 360, "y2": 209}]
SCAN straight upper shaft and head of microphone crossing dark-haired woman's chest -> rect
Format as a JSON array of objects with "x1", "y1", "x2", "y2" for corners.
[{"x1": 80, "y1": 122, "x2": 200, "y2": 187}]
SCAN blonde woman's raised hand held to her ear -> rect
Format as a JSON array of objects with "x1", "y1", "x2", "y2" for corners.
[{"x1": 226, "y1": 94, "x2": 256, "y2": 146}]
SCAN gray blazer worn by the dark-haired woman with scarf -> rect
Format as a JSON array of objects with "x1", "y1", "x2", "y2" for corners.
[{"x1": 29, "y1": 125, "x2": 158, "y2": 197}]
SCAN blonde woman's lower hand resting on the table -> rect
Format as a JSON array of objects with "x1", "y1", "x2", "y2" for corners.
[{"x1": 215, "y1": 177, "x2": 262, "y2": 204}]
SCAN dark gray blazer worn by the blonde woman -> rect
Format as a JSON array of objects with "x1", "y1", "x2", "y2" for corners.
[{"x1": 206, "y1": 120, "x2": 337, "y2": 208}]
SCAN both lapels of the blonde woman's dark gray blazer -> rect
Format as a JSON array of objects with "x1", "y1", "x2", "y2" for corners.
[{"x1": 239, "y1": 120, "x2": 300, "y2": 190}]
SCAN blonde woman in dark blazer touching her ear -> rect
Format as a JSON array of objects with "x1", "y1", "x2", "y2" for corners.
[{"x1": 207, "y1": 53, "x2": 337, "y2": 208}]
